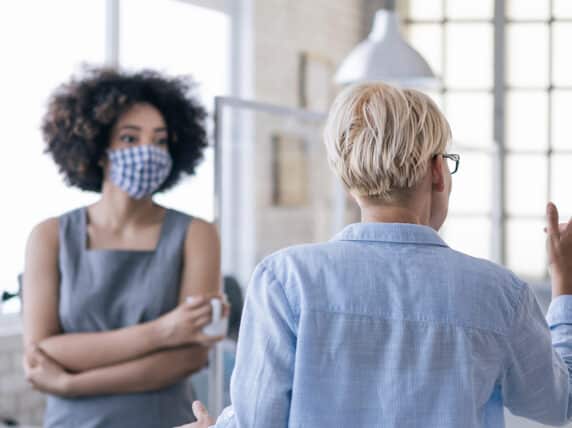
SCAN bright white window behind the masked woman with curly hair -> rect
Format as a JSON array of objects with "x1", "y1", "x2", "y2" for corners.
[{"x1": 0, "y1": 0, "x2": 230, "y2": 313}]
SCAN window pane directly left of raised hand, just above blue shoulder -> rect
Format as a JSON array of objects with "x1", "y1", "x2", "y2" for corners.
[{"x1": 507, "y1": 219, "x2": 547, "y2": 279}]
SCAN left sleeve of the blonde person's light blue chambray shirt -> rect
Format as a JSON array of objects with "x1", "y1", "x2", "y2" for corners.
[{"x1": 215, "y1": 264, "x2": 296, "y2": 428}]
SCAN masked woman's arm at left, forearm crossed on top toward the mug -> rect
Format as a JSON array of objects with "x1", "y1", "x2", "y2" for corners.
[{"x1": 24, "y1": 219, "x2": 214, "y2": 372}]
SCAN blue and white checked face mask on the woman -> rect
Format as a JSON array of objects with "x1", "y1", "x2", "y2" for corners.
[{"x1": 107, "y1": 144, "x2": 173, "y2": 199}]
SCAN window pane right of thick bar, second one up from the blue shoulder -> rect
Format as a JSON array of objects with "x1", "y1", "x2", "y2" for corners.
[{"x1": 506, "y1": 155, "x2": 548, "y2": 216}]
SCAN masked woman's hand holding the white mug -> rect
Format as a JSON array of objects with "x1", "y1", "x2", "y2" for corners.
[{"x1": 157, "y1": 297, "x2": 228, "y2": 347}]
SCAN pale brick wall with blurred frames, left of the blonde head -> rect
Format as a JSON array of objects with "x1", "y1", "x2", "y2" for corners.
[{"x1": 252, "y1": 0, "x2": 368, "y2": 261}]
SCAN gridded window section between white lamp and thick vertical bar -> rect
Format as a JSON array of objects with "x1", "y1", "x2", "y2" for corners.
[{"x1": 402, "y1": 0, "x2": 494, "y2": 258}]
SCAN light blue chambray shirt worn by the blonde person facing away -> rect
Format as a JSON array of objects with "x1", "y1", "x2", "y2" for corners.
[{"x1": 212, "y1": 223, "x2": 572, "y2": 428}]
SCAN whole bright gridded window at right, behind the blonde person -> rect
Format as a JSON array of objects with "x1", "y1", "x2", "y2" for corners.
[{"x1": 399, "y1": 0, "x2": 572, "y2": 280}]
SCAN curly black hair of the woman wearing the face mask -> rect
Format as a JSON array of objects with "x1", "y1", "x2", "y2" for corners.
[{"x1": 42, "y1": 67, "x2": 208, "y2": 192}]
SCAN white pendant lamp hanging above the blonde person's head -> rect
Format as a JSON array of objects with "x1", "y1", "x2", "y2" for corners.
[{"x1": 335, "y1": 9, "x2": 439, "y2": 88}]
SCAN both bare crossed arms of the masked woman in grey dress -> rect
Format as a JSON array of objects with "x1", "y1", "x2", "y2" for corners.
[{"x1": 23, "y1": 219, "x2": 220, "y2": 396}]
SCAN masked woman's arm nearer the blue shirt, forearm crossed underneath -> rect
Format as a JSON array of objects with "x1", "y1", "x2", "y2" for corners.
[{"x1": 27, "y1": 220, "x2": 220, "y2": 395}]
